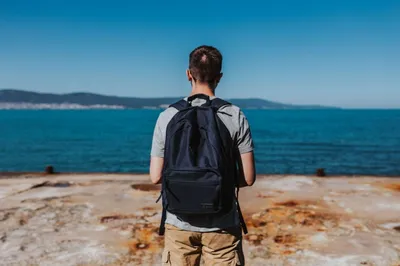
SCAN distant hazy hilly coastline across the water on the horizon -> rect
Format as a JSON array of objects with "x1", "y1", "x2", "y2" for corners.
[{"x1": 0, "y1": 89, "x2": 335, "y2": 109}]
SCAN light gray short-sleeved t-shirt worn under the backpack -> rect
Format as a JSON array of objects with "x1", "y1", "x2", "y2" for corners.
[{"x1": 151, "y1": 97, "x2": 253, "y2": 232}]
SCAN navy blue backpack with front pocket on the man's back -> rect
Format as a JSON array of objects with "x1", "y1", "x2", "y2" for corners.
[{"x1": 159, "y1": 94, "x2": 247, "y2": 235}]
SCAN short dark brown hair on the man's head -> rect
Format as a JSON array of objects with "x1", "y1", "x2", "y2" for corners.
[{"x1": 189, "y1": 45, "x2": 222, "y2": 83}]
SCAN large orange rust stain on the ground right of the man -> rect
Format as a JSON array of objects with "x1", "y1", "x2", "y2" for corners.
[{"x1": 244, "y1": 200, "x2": 340, "y2": 255}]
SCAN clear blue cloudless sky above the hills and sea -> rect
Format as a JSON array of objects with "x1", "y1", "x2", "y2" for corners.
[{"x1": 0, "y1": 0, "x2": 400, "y2": 108}]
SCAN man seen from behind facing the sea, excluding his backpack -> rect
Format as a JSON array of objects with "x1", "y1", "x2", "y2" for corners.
[{"x1": 150, "y1": 46, "x2": 256, "y2": 266}]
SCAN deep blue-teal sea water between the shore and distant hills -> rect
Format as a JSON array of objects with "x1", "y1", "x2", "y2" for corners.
[{"x1": 0, "y1": 110, "x2": 400, "y2": 176}]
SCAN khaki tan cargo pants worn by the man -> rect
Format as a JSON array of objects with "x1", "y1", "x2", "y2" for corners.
[{"x1": 162, "y1": 224, "x2": 244, "y2": 266}]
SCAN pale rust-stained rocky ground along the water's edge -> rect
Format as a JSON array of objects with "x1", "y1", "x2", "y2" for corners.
[{"x1": 0, "y1": 174, "x2": 400, "y2": 266}]
